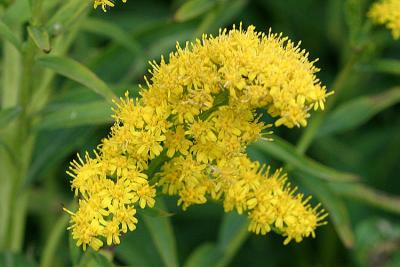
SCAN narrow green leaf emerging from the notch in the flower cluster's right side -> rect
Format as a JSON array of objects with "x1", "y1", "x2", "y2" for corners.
[{"x1": 251, "y1": 136, "x2": 358, "y2": 182}]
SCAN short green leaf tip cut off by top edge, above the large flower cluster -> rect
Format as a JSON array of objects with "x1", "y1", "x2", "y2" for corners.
[{"x1": 174, "y1": 0, "x2": 216, "y2": 22}]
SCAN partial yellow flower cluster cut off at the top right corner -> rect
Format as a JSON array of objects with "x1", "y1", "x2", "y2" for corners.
[{"x1": 368, "y1": 0, "x2": 400, "y2": 39}]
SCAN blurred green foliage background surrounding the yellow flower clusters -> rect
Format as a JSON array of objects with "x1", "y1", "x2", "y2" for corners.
[{"x1": 0, "y1": 0, "x2": 400, "y2": 267}]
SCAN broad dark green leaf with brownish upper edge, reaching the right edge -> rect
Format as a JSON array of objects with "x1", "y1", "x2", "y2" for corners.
[{"x1": 317, "y1": 87, "x2": 400, "y2": 137}]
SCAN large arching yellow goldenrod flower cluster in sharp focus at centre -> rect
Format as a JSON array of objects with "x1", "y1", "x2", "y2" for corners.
[{"x1": 68, "y1": 26, "x2": 328, "y2": 249}]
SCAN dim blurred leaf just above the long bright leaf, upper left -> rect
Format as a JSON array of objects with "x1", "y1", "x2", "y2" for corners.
[{"x1": 82, "y1": 18, "x2": 142, "y2": 55}]
